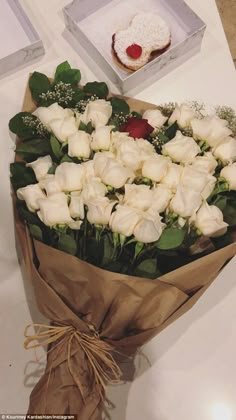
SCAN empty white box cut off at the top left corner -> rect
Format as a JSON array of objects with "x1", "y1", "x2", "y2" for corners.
[{"x1": 0, "y1": 0, "x2": 44, "y2": 75}]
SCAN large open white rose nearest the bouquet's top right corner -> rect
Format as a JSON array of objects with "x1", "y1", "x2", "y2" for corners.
[{"x1": 191, "y1": 116, "x2": 232, "y2": 147}]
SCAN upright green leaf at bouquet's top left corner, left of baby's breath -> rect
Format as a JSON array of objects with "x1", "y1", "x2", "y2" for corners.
[{"x1": 29, "y1": 71, "x2": 52, "y2": 105}]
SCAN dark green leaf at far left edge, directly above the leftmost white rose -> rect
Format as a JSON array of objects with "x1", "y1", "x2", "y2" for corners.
[{"x1": 10, "y1": 162, "x2": 37, "y2": 191}]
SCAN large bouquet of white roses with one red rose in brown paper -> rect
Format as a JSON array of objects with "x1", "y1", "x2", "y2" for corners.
[{"x1": 9, "y1": 62, "x2": 236, "y2": 419}]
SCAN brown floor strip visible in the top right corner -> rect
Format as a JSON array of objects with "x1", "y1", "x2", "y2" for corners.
[{"x1": 216, "y1": 0, "x2": 236, "y2": 65}]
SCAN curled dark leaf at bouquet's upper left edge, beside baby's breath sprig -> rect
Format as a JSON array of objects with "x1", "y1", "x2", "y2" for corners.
[{"x1": 9, "y1": 112, "x2": 38, "y2": 139}]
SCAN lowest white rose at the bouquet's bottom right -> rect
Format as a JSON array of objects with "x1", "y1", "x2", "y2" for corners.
[{"x1": 195, "y1": 202, "x2": 228, "y2": 238}]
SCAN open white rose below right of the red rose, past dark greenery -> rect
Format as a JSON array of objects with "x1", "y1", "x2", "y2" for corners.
[{"x1": 162, "y1": 131, "x2": 201, "y2": 163}]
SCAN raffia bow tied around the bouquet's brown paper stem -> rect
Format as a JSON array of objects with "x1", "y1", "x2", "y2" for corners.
[{"x1": 24, "y1": 324, "x2": 122, "y2": 402}]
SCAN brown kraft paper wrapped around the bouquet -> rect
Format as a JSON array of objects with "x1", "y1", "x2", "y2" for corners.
[{"x1": 13, "y1": 84, "x2": 236, "y2": 420}]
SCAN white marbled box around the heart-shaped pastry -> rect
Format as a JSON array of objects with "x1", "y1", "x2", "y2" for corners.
[{"x1": 64, "y1": 0, "x2": 206, "y2": 93}]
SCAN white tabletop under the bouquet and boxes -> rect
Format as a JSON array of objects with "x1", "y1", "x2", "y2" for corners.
[{"x1": 0, "y1": 0, "x2": 236, "y2": 420}]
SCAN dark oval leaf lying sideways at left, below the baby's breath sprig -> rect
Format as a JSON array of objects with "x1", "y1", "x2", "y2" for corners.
[{"x1": 16, "y1": 139, "x2": 51, "y2": 162}]
